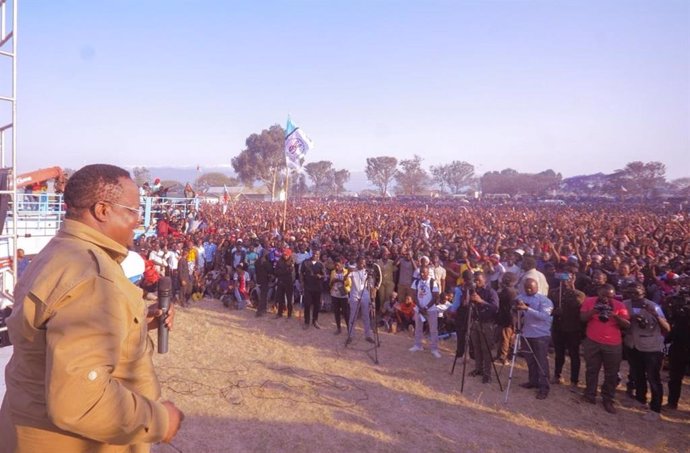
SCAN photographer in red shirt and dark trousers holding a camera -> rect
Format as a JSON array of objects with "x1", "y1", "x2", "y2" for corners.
[{"x1": 580, "y1": 284, "x2": 630, "y2": 414}]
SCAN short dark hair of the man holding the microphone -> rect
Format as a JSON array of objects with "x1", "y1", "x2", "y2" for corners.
[{"x1": 64, "y1": 164, "x2": 130, "y2": 219}]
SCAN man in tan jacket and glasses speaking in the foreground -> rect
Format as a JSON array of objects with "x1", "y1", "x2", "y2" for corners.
[{"x1": 0, "y1": 164, "x2": 184, "y2": 453}]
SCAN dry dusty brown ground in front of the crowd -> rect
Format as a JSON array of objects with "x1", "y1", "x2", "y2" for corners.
[{"x1": 153, "y1": 300, "x2": 690, "y2": 453}]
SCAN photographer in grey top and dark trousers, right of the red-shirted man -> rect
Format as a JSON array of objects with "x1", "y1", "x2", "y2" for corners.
[{"x1": 623, "y1": 283, "x2": 671, "y2": 421}]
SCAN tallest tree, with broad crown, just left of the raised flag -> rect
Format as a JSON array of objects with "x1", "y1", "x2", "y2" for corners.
[{"x1": 232, "y1": 124, "x2": 285, "y2": 199}]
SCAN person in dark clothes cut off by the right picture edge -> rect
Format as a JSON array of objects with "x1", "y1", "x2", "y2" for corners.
[{"x1": 664, "y1": 280, "x2": 690, "y2": 409}]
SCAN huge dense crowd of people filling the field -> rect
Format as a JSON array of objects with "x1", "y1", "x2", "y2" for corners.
[{"x1": 130, "y1": 193, "x2": 690, "y2": 419}]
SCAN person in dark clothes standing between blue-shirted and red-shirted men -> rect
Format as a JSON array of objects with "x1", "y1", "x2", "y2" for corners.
[{"x1": 549, "y1": 268, "x2": 585, "y2": 388}]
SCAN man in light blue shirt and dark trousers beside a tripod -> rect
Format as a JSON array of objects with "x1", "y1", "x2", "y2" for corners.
[{"x1": 515, "y1": 278, "x2": 553, "y2": 400}]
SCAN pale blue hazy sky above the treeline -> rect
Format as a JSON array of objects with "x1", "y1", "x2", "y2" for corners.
[{"x1": 10, "y1": 0, "x2": 690, "y2": 179}]
